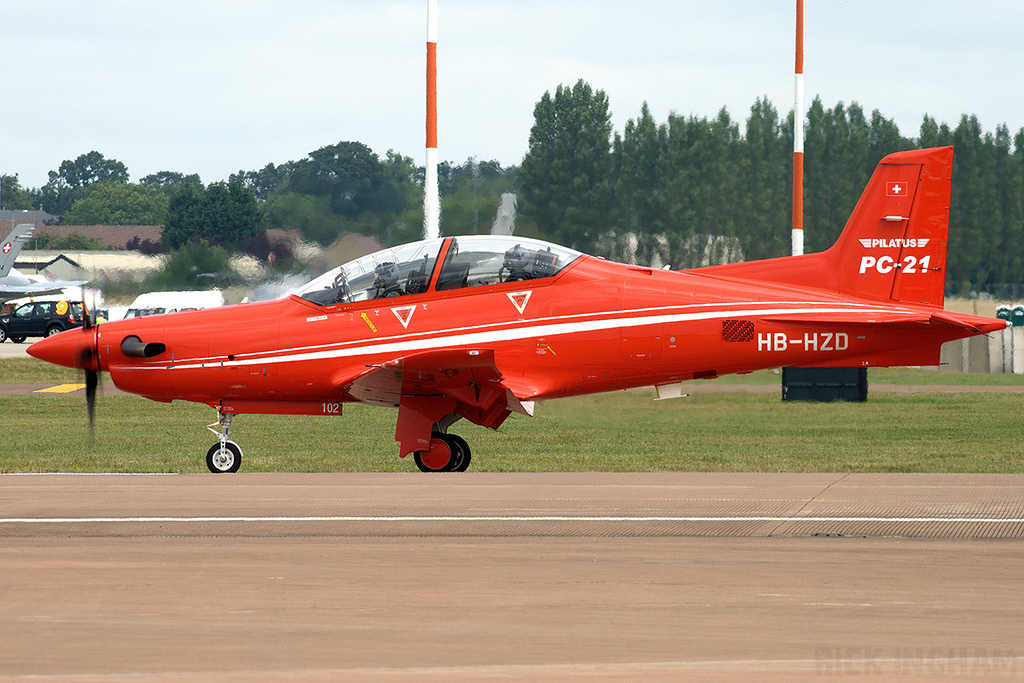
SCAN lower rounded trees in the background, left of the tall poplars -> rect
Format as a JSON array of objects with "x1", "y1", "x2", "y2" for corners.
[{"x1": 0, "y1": 141, "x2": 517, "y2": 265}]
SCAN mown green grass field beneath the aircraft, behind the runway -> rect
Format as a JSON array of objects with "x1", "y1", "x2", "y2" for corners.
[{"x1": 0, "y1": 359, "x2": 1024, "y2": 472}]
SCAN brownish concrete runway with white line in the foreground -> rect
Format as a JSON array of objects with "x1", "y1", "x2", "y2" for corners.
[{"x1": 0, "y1": 473, "x2": 1024, "y2": 682}]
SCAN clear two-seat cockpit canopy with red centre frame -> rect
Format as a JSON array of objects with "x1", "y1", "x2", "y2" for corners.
[{"x1": 296, "y1": 236, "x2": 582, "y2": 305}]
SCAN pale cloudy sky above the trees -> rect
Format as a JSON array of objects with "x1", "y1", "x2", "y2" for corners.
[{"x1": 0, "y1": 0, "x2": 1024, "y2": 187}]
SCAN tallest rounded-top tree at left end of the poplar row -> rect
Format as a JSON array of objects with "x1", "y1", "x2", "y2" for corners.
[{"x1": 519, "y1": 79, "x2": 612, "y2": 250}]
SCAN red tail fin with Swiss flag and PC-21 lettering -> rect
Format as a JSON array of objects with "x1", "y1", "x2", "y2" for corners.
[{"x1": 693, "y1": 147, "x2": 953, "y2": 308}]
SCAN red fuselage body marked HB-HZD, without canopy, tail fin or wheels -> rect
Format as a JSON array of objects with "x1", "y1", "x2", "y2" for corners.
[{"x1": 56, "y1": 256, "x2": 1002, "y2": 413}]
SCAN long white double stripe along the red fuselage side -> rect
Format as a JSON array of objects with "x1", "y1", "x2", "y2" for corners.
[{"x1": 159, "y1": 302, "x2": 911, "y2": 370}]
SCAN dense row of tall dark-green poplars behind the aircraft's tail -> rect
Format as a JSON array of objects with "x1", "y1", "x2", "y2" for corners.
[{"x1": 520, "y1": 81, "x2": 1024, "y2": 291}]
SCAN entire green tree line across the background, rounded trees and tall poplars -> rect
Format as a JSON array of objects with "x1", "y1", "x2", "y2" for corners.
[{"x1": 0, "y1": 80, "x2": 1024, "y2": 291}]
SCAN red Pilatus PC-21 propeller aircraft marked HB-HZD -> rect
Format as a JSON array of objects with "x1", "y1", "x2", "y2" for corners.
[{"x1": 29, "y1": 147, "x2": 1006, "y2": 472}]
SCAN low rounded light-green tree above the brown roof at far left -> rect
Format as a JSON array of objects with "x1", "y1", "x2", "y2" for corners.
[{"x1": 63, "y1": 181, "x2": 168, "y2": 225}]
